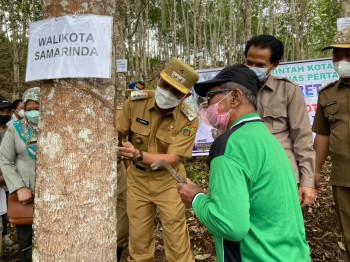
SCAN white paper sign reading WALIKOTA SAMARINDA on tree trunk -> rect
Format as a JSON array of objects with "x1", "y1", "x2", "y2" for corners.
[{"x1": 26, "y1": 15, "x2": 113, "y2": 81}]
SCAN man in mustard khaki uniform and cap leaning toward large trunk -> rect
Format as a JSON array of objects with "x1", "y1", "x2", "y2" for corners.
[{"x1": 117, "y1": 58, "x2": 199, "y2": 262}]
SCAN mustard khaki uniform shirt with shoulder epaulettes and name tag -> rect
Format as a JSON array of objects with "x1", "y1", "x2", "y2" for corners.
[{"x1": 117, "y1": 90, "x2": 198, "y2": 177}]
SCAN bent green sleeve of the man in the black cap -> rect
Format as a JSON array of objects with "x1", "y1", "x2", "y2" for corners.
[{"x1": 192, "y1": 156, "x2": 250, "y2": 241}]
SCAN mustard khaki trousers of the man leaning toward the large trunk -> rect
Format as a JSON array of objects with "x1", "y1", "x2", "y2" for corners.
[{"x1": 127, "y1": 166, "x2": 194, "y2": 262}]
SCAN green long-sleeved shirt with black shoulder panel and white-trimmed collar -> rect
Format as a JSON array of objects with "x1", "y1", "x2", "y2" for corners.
[{"x1": 193, "y1": 114, "x2": 310, "y2": 262}]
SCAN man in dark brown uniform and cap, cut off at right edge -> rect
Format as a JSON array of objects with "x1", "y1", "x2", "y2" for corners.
[{"x1": 312, "y1": 28, "x2": 350, "y2": 261}]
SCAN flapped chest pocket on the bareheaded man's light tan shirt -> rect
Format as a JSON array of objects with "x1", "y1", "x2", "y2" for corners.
[{"x1": 264, "y1": 107, "x2": 288, "y2": 134}]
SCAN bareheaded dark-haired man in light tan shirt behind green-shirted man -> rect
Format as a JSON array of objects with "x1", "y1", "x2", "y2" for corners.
[{"x1": 245, "y1": 35, "x2": 316, "y2": 207}]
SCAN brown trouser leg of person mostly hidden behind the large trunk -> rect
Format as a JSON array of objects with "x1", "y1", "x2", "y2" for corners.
[{"x1": 117, "y1": 163, "x2": 129, "y2": 247}]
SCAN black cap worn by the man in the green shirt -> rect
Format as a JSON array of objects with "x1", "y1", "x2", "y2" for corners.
[{"x1": 194, "y1": 64, "x2": 261, "y2": 96}]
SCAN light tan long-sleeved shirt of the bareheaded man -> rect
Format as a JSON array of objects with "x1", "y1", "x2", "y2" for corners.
[{"x1": 257, "y1": 75, "x2": 315, "y2": 187}]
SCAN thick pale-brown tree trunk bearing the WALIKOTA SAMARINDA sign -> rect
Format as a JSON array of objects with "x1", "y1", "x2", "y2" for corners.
[{"x1": 33, "y1": 0, "x2": 118, "y2": 262}]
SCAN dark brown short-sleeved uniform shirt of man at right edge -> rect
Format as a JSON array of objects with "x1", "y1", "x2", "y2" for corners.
[{"x1": 312, "y1": 81, "x2": 350, "y2": 187}]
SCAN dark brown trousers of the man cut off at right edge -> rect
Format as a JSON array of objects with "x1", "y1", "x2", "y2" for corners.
[{"x1": 332, "y1": 186, "x2": 350, "y2": 262}]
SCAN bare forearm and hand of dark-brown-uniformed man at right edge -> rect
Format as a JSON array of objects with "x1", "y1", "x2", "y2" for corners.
[{"x1": 314, "y1": 134, "x2": 329, "y2": 188}]
